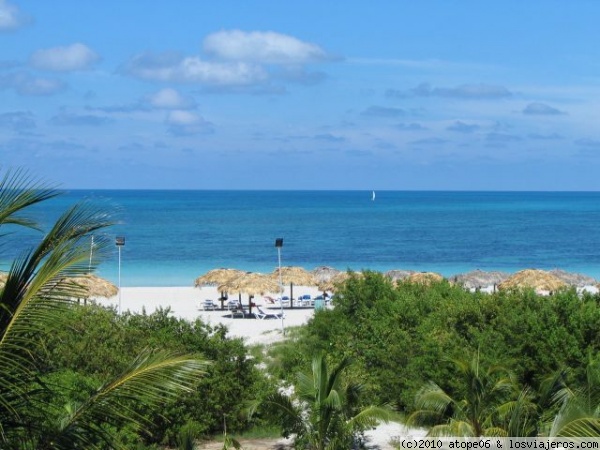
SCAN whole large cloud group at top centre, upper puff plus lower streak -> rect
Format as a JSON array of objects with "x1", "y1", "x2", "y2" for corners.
[{"x1": 122, "y1": 30, "x2": 333, "y2": 89}]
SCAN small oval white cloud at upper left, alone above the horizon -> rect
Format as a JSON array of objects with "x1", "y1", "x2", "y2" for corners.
[{"x1": 29, "y1": 43, "x2": 100, "y2": 72}]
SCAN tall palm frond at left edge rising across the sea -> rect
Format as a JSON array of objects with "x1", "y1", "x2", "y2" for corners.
[{"x1": 0, "y1": 192, "x2": 112, "y2": 443}]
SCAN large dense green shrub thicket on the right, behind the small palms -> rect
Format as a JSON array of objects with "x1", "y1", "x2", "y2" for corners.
[{"x1": 271, "y1": 273, "x2": 600, "y2": 433}]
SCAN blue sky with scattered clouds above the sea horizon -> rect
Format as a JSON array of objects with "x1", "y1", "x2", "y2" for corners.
[{"x1": 0, "y1": 0, "x2": 600, "y2": 191}]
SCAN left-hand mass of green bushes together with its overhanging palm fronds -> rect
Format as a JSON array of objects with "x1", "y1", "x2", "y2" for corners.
[{"x1": 0, "y1": 171, "x2": 268, "y2": 449}]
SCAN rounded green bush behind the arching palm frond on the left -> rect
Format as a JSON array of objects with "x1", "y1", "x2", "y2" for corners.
[{"x1": 39, "y1": 305, "x2": 274, "y2": 445}]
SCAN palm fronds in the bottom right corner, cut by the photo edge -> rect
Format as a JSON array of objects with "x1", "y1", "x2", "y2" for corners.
[{"x1": 549, "y1": 357, "x2": 600, "y2": 437}]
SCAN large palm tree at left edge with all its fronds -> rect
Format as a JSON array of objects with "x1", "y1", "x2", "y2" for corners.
[{"x1": 0, "y1": 171, "x2": 206, "y2": 449}]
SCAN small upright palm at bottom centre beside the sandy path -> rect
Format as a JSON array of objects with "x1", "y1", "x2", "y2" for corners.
[{"x1": 252, "y1": 355, "x2": 393, "y2": 450}]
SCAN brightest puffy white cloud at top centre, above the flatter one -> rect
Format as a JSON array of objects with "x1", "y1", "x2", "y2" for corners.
[{"x1": 203, "y1": 30, "x2": 329, "y2": 64}]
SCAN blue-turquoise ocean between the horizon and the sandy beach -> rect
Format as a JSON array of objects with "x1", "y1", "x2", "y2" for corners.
[{"x1": 0, "y1": 190, "x2": 600, "y2": 286}]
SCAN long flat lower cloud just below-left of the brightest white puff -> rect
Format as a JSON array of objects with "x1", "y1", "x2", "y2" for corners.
[{"x1": 124, "y1": 53, "x2": 267, "y2": 86}]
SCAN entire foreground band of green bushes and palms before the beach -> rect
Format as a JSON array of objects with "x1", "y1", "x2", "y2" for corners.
[{"x1": 0, "y1": 172, "x2": 600, "y2": 450}]
